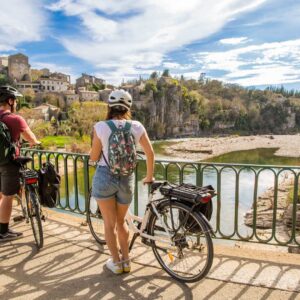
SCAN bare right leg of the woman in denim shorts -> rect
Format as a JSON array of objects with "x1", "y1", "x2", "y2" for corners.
[{"x1": 117, "y1": 203, "x2": 129, "y2": 260}]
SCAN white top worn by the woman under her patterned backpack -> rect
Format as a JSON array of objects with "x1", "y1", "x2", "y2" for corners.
[{"x1": 94, "y1": 120, "x2": 146, "y2": 166}]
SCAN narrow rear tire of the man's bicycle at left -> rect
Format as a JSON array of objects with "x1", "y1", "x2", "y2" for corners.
[{"x1": 25, "y1": 186, "x2": 44, "y2": 249}]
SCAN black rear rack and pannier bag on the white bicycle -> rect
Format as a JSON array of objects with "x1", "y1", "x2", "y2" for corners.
[{"x1": 160, "y1": 183, "x2": 216, "y2": 234}]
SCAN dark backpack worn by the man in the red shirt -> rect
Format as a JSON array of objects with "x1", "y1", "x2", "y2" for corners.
[{"x1": 0, "y1": 113, "x2": 16, "y2": 166}]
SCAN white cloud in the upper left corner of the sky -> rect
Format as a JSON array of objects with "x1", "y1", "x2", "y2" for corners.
[{"x1": 0, "y1": 0, "x2": 47, "y2": 51}]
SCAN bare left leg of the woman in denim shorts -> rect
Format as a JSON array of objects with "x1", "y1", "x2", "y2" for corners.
[{"x1": 97, "y1": 198, "x2": 120, "y2": 262}]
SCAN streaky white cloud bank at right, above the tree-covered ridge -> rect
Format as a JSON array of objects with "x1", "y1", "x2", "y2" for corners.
[{"x1": 195, "y1": 39, "x2": 300, "y2": 86}]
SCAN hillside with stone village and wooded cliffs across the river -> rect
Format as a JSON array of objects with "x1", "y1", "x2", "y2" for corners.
[{"x1": 0, "y1": 53, "x2": 300, "y2": 146}]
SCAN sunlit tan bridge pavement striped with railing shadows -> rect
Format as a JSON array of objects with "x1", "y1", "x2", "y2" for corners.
[{"x1": 0, "y1": 209, "x2": 300, "y2": 300}]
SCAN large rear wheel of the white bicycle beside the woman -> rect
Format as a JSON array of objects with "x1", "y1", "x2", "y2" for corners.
[{"x1": 148, "y1": 201, "x2": 213, "y2": 282}]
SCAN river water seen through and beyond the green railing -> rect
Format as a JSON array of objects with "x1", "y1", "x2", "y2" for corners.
[{"x1": 61, "y1": 142, "x2": 300, "y2": 236}]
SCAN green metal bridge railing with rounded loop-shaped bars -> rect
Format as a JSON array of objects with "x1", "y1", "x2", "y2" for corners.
[{"x1": 22, "y1": 149, "x2": 300, "y2": 246}]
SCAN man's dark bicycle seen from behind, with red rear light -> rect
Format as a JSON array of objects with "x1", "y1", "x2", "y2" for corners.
[{"x1": 14, "y1": 156, "x2": 45, "y2": 249}]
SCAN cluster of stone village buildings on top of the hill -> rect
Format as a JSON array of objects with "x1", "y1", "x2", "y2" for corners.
[{"x1": 0, "y1": 53, "x2": 111, "y2": 110}]
